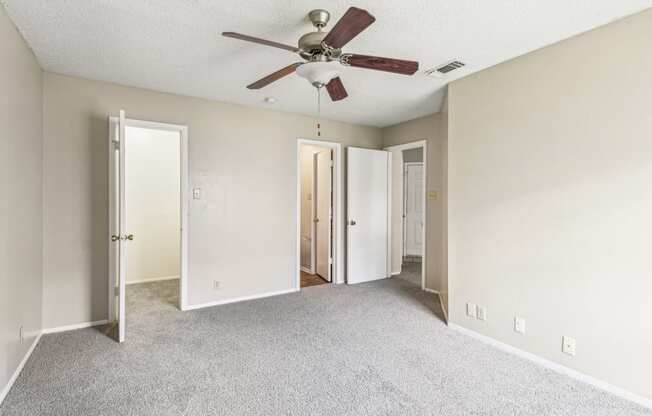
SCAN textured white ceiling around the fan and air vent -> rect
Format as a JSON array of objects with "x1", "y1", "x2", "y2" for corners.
[{"x1": 0, "y1": 0, "x2": 652, "y2": 127}]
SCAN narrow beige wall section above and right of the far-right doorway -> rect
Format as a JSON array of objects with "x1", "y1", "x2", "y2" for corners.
[{"x1": 382, "y1": 113, "x2": 444, "y2": 291}]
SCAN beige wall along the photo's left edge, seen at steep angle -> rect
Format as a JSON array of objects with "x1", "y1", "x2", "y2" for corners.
[{"x1": 0, "y1": 6, "x2": 43, "y2": 394}]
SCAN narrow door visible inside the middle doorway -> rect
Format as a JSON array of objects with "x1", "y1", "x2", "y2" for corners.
[{"x1": 315, "y1": 150, "x2": 333, "y2": 282}]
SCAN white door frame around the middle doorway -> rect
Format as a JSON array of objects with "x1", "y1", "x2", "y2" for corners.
[{"x1": 295, "y1": 138, "x2": 344, "y2": 290}]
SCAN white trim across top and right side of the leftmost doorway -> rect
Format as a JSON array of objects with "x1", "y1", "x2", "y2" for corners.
[{"x1": 109, "y1": 117, "x2": 190, "y2": 312}]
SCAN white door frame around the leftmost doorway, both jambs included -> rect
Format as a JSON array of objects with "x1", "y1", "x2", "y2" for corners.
[{"x1": 108, "y1": 117, "x2": 190, "y2": 321}]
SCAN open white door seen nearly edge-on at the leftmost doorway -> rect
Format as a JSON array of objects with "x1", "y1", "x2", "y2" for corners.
[{"x1": 109, "y1": 110, "x2": 128, "y2": 342}]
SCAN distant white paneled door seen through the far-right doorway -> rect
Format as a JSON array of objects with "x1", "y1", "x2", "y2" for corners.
[{"x1": 404, "y1": 163, "x2": 425, "y2": 256}]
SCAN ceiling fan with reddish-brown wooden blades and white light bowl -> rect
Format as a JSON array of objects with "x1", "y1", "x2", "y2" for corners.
[{"x1": 222, "y1": 7, "x2": 419, "y2": 101}]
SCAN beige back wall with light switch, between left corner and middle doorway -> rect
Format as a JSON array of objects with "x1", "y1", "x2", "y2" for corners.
[{"x1": 44, "y1": 73, "x2": 382, "y2": 327}]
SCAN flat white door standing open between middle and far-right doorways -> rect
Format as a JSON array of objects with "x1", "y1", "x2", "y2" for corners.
[{"x1": 347, "y1": 147, "x2": 391, "y2": 283}]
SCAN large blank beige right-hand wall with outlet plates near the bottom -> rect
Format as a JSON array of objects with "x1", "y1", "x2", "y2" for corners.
[{"x1": 448, "y1": 11, "x2": 652, "y2": 399}]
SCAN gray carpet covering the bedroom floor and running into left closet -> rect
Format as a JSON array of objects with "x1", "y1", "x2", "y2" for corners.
[{"x1": 0, "y1": 279, "x2": 652, "y2": 416}]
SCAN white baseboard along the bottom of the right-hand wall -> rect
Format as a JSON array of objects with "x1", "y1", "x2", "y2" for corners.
[{"x1": 448, "y1": 323, "x2": 652, "y2": 409}]
